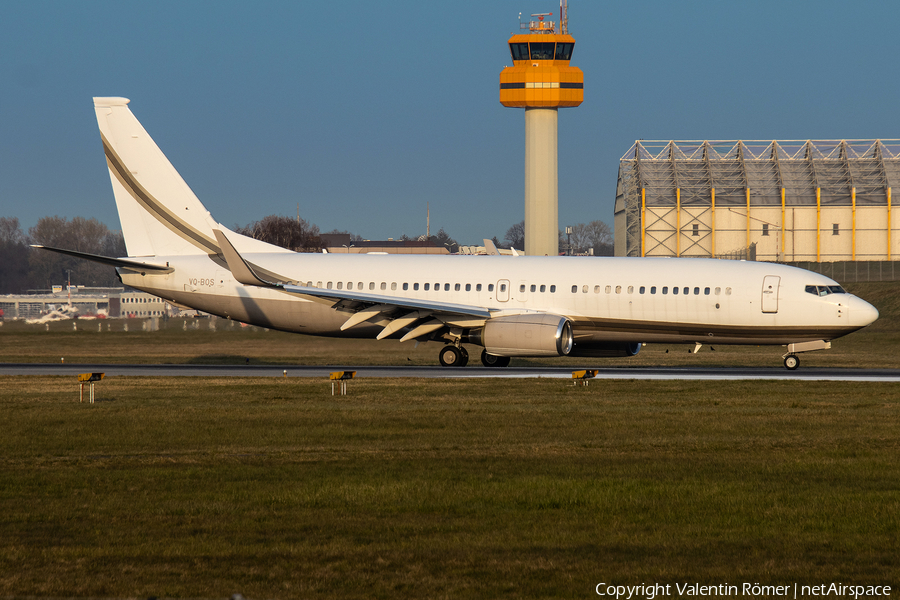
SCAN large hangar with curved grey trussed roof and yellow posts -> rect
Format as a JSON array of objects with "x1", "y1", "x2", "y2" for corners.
[{"x1": 615, "y1": 140, "x2": 900, "y2": 267}]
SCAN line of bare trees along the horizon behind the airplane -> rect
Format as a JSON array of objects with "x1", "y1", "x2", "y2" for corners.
[{"x1": 0, "y1": 215, "x2": 613, "y2": 294}]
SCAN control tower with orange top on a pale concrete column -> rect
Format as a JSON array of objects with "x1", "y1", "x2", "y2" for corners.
[{"x1": 500, "y1": 6, "x2": 584, "y2": 256}]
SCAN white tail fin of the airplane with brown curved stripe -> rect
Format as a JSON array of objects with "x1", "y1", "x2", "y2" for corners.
[{"x1": 94, "y1": 98, "x2": 220, "y2": 256}]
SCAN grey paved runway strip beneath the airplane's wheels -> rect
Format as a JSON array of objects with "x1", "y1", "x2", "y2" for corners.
[{"x1": 0, "y1": 363, "x2": 900, "y2": 382}]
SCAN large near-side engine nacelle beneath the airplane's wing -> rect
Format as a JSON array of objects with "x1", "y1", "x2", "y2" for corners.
[{"x1": 468, "y1": 313, "x2": 574, "y2": 356}]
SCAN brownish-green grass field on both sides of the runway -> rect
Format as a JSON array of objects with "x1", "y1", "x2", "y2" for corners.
[{"x1": 0, "y1": 284, "x2": 900, "y2": 600}]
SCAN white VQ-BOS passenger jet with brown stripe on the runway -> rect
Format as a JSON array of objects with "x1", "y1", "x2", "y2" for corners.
[{"x1": 35, "y1": 98, "x2": 878, "y2": 369}]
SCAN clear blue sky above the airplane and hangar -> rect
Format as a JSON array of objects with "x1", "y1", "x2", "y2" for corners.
[{"x1": 0, "y1": 0, "x2": 900, "y2": 243}]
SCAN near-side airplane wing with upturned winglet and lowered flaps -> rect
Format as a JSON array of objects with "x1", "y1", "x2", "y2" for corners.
[{"x1": 214, "y1": 229, "x2": 491, "y2": 341}]
